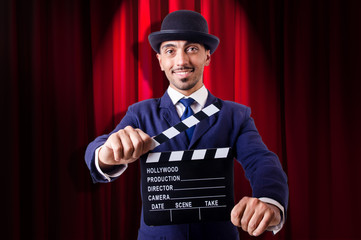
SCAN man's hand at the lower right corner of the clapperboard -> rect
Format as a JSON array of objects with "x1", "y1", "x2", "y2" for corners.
[{"x1": 231, "y1": 197, "x2": 281, "y2": 236}]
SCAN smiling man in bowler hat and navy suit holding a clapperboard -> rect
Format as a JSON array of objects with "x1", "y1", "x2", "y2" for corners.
[{"x1": 85, "y1": 10, "x2": 288, "y2": 239}]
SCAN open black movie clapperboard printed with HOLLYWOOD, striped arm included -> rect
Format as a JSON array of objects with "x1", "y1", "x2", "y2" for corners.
[{"x1": 140, "y1": 104, "x2": 234, "y2": 226}]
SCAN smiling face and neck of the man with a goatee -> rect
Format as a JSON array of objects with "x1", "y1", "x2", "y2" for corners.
[{"x1": 157, "y1": 40, "x2": 211, "y2": 96}]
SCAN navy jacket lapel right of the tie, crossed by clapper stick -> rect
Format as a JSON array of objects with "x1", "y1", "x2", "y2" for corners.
[{"x1": 189, "y1": 91, "x2": 219, "y2": 149}]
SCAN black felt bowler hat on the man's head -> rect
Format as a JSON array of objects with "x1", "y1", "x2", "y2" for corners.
[{"x1": 148, "y1": 10, "x2": 219, "y2": 54}]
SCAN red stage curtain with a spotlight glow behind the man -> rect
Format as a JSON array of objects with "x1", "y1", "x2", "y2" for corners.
[{"x1": 0, "y1": 0, "x2": 361, "y2": 240}]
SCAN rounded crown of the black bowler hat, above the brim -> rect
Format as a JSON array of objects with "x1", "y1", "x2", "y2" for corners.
[{"x1": 161, "y1": 10, "x2": 208, "y2": 33}]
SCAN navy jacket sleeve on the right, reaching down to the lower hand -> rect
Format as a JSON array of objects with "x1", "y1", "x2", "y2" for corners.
[{"x1": 236, "y1": 108, "x2": 289, "y2": 214}]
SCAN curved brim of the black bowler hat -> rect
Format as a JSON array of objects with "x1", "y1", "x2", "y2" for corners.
[{"x1": 148, "y1": 30, "x2": 219, "y2": 54}]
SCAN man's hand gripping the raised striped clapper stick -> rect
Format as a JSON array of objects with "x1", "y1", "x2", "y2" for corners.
[{"x1": 99, "y1": 126, "x2": 152, "y2": 170}]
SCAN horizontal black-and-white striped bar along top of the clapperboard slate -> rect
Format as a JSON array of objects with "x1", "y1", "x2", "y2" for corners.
[{"x1": 146, "y1": 147, "x2": 231, "y2": 163}]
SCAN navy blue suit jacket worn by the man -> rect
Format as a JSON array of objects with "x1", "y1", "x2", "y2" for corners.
[{"x1": 85, "y1": 93, "x2": 288, "y2": 239}]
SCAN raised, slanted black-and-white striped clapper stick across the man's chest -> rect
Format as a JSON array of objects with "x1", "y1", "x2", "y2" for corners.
[{"x1": 152, "y1": 102, "x2": 221, "y2": 149}]
